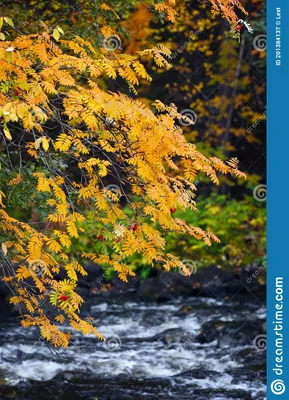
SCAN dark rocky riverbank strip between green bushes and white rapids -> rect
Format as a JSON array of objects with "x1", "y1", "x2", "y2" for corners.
[{"x1": 75, "y1": 263, "x2": 266, "y2": 301}]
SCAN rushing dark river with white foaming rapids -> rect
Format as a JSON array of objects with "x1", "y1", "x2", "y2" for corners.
[{"x1": 0, "y1": 298, "x2": 266, "y2": 400}]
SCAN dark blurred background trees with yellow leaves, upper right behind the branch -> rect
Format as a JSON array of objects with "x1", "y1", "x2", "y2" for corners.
[{"x1": 127, "y1": 0, "x2": 266, "y2": 178}]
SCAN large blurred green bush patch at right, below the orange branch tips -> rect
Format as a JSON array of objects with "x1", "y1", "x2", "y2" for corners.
[{"x1": 163, "y1": 193, "x2": 266, "y2": 267}]
